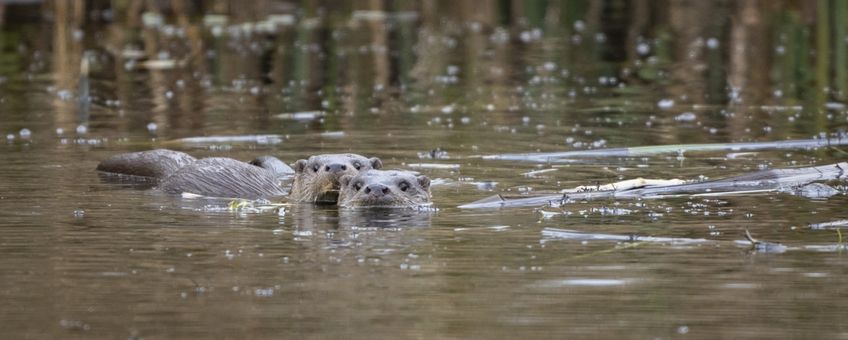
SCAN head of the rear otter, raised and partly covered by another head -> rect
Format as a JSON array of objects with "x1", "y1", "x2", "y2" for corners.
[{"x1": 289, "y1": 153, "x2": 383, "y2": 203}]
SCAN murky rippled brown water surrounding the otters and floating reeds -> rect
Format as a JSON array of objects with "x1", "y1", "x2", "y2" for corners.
[{"x1": 0, "y1": 1, "x2": 848, "y2": 338}]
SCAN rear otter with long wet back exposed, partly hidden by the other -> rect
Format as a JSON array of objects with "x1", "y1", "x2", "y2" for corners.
[{"x1": 97, "y1": 149, "x2": 382, "y2": 203}]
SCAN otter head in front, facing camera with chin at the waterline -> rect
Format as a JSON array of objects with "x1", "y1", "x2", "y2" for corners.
[{"x1": 339, "y1": 170, "x2": 430, "y2": 208}]
